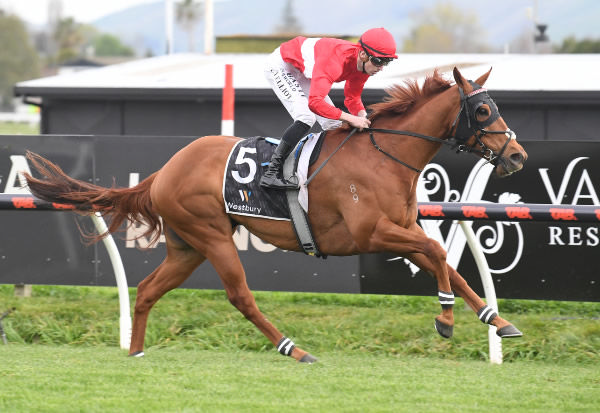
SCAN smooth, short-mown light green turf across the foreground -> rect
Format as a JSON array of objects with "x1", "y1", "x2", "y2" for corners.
[{"x1": 0, "y1": 344, "x2": 600, "y2": 413}]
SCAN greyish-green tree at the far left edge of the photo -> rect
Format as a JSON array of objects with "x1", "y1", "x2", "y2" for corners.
[{"x1": 0, "y1": 10, "x2": 40, "y2": 110}]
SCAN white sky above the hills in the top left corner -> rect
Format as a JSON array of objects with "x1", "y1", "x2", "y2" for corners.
[{"x1": 0, "y1": 0, "x2": 156, "y2": 25}]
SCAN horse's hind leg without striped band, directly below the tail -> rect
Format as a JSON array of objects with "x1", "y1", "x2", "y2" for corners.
[{"x1": 129, "y1": 227, "x2": 205, "y2": 357}]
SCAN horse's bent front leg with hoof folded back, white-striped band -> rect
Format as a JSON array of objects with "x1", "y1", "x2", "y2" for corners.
[{"x1": 369, "y1": 218, "x2": 454, "y2": 338}]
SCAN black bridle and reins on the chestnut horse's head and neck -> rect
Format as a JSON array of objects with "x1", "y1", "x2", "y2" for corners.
[{"x1": 363, "y1": 80, "x2": 516, "y2": 173}]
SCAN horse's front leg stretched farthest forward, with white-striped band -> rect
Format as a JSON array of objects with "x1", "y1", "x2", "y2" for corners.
[{"x1": 406, "y1": 254, "x2": 523, "y2": 337}]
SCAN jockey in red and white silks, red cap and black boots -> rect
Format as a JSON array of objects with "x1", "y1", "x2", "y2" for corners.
[{"x1": 260, "y1": 28, "x2": 398, "y2": 189}]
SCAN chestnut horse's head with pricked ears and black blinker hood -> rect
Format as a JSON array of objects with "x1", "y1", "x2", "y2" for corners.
[{"x1": 453, "y1": 67, "x2": 527, "y2": 176}]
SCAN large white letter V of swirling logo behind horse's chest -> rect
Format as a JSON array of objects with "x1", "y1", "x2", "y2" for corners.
[{"x1": 417, "y1": 159, "x2": 494, "y2": 268}]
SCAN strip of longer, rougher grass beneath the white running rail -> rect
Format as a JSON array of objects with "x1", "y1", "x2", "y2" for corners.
[{"x1": 0, "y1": 285, "x2": 600, "y2": 363}]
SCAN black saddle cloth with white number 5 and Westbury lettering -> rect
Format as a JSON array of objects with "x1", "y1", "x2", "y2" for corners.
[{"x1": 223, "y1": 133, "x2": 321, "y2": 221}]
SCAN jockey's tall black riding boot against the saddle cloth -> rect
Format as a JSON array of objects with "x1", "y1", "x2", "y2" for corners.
[{"x1": 260, "y1": 120, "x2": 311, "y2": 189}]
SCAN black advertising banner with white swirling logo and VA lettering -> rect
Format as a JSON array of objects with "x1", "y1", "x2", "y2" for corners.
[{"x1": 360, "y1": 141, "x2": 600, "y2": 301}]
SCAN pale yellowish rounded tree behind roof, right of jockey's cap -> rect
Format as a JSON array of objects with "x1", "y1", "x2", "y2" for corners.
[{"x1": 403, "y1": 3, "x2": 490, "y2": 53}]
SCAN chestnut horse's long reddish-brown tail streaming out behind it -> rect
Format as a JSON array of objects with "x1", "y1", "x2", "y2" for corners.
[{"x1": 24, "y1": 151, "x2": 162, "y2": 243}]
